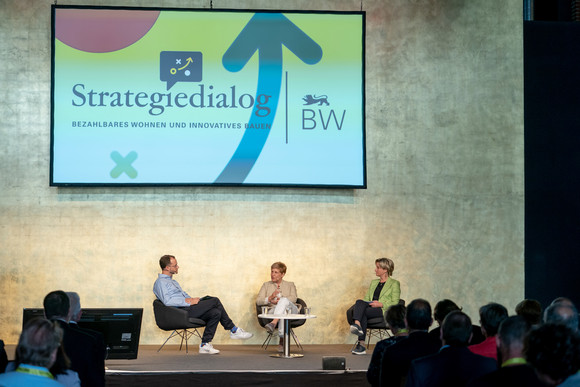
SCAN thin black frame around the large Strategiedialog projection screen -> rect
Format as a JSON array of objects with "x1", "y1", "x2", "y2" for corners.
[{"x1": 49, "y1": 4, "x2": 367, "y2": 189}]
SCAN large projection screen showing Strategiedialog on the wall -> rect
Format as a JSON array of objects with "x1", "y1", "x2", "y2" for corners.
[{"x1": 50, "y1": 5, "x2": 366, "y2": 188}]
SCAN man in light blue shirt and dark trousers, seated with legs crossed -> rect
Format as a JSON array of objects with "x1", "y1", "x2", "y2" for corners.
[{"x1": 153, "y1": 255, "x2": 253, "y2": 355}]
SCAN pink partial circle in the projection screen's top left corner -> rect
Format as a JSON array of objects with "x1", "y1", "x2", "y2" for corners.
[{"x1": 55, "y1": 8, "x2": 160, "y2": 53}]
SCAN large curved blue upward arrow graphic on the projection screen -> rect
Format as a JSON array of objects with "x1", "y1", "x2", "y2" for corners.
[{"x1": 215, "y1": 13, "x2": 322, "y2": 183}]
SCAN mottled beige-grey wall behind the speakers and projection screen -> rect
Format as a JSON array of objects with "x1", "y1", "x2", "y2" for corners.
[{"x1": 0, "y1": 0, "x2": 524, "y2": 344}]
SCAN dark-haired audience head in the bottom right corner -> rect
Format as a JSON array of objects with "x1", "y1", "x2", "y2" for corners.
[{"x1": 524, "y1": 324, "x2": 580, "y2": 386}]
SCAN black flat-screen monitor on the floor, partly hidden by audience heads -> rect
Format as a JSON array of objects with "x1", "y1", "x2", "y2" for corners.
[{"x1": 22, "y1": 308, "x2": 143, "y2": 359}]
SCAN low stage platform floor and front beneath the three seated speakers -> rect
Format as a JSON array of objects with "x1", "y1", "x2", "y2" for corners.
[{"x1": 6, "y1": 342, "x2": 374, "y2": 387}]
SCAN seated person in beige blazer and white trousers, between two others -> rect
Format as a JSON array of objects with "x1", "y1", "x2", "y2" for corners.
[{"x1": 256, "y1": 262, "x2": 298, "y2": 349}]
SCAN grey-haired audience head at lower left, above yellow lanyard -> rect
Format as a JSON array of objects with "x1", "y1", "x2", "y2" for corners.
[{"x1": 16, "y1": 318, "x2": 62, "y2": 368}]
